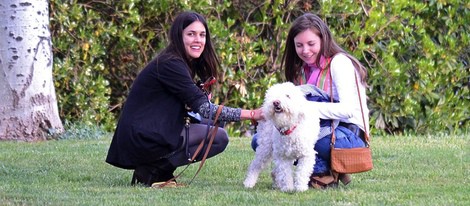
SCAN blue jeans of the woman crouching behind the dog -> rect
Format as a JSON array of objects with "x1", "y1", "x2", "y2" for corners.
[{"x1": 251, "y1": 126, "x2": 365, "y2": 174}]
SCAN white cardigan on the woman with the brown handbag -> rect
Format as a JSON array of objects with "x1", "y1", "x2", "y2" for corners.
[{"x1": 311, "y1": 53, "x2": 369, "y2": 132}]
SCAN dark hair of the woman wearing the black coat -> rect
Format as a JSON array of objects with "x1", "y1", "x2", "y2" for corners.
[{"x1": 157, "y1": 11, "x2": 220, "y2": 80}]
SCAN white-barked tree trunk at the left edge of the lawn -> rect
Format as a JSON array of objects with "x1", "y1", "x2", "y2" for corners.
[{"x1": 0, "y1": 0, "x2": 64, "y2": 141}]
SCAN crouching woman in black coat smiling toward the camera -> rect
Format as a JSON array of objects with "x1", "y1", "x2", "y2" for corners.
[{"x1": 106, "y1": 12, "x2": 262, "y2": 186}]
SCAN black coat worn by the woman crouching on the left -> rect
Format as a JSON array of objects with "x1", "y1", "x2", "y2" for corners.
[{"x1": 106, "y1": 56, "x2": 208, "y2": 169}]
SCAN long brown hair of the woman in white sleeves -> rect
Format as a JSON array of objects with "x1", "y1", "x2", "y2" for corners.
[{"x1": 281, "y1": 13, "x2": 367, "y2": 85}]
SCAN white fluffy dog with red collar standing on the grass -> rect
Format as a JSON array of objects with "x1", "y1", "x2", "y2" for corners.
[{"x1": 244, "y1": 82, "x2": 320, "y2": 192}]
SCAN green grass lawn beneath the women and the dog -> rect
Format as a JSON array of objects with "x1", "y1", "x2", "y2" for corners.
[{"x1": 0, "y1": 135, "x2": 470, "y2": 206}]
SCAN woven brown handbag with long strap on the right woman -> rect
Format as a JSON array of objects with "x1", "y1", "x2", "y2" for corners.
[{"x1": 330, "y1": 65, "x2": 374, "y2": 174}]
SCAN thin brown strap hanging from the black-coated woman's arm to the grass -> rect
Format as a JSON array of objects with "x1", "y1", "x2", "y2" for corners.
[{"x1": 158, "y1": 104, "x2": 223, "y2": 188}]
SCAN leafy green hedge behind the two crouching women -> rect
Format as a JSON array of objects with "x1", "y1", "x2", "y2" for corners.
[{"x1": 50, "y1": 0, "x2": 470, "y2": 135}]
